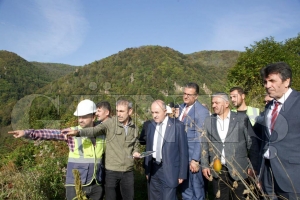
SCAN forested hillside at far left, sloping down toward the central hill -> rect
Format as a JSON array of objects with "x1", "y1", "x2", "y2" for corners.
[{"x1": 0, "y1": 51, "x2": 75, "y2": 126}]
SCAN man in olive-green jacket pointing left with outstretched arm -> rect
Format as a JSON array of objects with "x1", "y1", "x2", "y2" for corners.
[{"x1": 65, "y1": 100, "x2": 140, "y2": 200}]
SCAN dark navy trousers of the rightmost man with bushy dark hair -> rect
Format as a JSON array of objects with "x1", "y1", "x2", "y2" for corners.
[{"x1": 262, "y1": 159, "x2": 300, "y2": 200}]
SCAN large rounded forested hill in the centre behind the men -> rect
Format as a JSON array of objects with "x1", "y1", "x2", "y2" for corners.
[{"x1": 41, "y1": 46, "x2": 239, "y2": 98}]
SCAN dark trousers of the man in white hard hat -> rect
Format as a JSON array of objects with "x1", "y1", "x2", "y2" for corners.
[{"x1": 66, "y1": 182, "x2": 104, "y2": 200}]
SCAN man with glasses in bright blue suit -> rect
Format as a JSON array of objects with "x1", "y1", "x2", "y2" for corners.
[{"x1": 178, "y1": 83, "x2": 209, "y2": 200}]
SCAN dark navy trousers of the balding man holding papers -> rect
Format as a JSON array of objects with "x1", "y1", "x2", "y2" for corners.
[{"x1": 149, "y1": 161, "x2": 177, "y2": 200}]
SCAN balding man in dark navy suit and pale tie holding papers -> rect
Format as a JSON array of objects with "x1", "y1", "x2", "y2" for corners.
[{"x1": 145, "y1": 100, "x2": 188, "y2": 200}]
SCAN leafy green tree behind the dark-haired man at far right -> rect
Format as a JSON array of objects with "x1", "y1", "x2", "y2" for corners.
[{"x1": 227, "y1": 34, "x2": 300, "y2": 106}]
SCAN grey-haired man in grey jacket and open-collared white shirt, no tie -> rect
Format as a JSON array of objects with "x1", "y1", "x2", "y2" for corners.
[{"x1": 201, "y1": 93, "x2": 253, "y2": 200}]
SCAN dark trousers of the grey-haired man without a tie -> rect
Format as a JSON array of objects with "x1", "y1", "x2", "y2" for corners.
[{"x1": 213, "y1": 166, "x2": 246, "y2": 200}]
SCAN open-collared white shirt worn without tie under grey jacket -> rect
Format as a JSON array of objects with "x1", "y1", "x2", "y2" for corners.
[{"x1": 217, "y1": 111, "x2": 230, "y2": 165}]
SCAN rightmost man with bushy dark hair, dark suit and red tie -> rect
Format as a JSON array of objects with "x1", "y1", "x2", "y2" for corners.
[{"x1": 254, "y1": 62, "x2": 300, "y2": 199}]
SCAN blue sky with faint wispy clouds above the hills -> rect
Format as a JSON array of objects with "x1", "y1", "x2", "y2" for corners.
[{"x1": 0, "y1": 0, "x2": 300, "y2": 66}]
